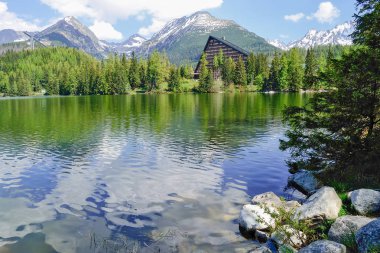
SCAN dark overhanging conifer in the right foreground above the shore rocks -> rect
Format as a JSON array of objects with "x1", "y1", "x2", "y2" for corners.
[{"x1": 281, "y1": 1, "x2": 380, "y2": 182}]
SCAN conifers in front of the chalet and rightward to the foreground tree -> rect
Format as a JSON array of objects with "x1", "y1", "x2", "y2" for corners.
[{"x1": 199, "y1": 47, "x2": 348, "y2": 92}]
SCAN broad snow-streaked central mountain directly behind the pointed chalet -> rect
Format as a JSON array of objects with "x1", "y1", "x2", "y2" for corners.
[{"x1": 138, "y1": 12, "x2": 278, "y2": 63}]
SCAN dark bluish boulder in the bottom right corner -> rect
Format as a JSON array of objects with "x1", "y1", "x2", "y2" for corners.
[{"x1": 355, "y1": 219, "x2": 380, "y2": 253}]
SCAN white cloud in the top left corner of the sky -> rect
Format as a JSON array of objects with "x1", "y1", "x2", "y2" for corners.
[{"x1": 0, "y1": 2, "x2": 41, "y2": 31}]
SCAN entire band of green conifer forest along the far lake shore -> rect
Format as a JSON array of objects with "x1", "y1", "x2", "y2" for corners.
[{"x1": 0, "y1": 44, "x2": 343, "y2": 96}]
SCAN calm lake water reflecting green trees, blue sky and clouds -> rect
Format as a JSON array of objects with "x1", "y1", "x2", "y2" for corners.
[{"x1": 0, "y1": 93, "x2": 307, "y2": 253}]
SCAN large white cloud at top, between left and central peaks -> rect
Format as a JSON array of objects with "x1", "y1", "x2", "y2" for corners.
[{"x1": 40, "y1": 0, "x2": 223, "y2": 36}]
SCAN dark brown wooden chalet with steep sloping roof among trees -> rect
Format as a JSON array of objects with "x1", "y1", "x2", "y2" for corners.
[{"x1": 194, "y1": 36, "x2": 248, "y2": 79}]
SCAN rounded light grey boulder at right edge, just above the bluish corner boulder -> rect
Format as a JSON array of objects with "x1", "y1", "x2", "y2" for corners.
[{"x1": 349, "y1": 189, "x2": 380, "y2": 215}]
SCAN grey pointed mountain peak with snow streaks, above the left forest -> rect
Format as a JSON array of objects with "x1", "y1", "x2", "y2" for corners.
[{"x1": 36, "y1": 17, "x2": 106, "y2": 57}]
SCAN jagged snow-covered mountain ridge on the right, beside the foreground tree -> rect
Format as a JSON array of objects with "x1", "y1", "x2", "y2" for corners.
[{"x1": 268, "y1": 22, "x2": 355, "y2": 50}]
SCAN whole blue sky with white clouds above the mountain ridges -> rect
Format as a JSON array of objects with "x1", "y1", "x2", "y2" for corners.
[{"x1": 0, "y1": 0, "x2": 355, "y2": 42}]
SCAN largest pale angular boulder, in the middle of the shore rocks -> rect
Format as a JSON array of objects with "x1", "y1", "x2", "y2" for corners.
[{"x1": 294, "y1": 186, "x2": 342, "y2": 223}]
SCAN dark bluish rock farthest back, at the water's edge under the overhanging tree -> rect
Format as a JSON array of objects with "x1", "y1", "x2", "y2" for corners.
[{"x1": 288, "y1": 170, "x2": 322, "y2": 195}]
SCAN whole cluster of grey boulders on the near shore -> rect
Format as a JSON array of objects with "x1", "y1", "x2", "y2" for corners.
[{"x1": 239, "y1": 171, "x2": 380, "y2": 253}]
